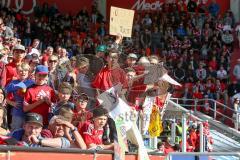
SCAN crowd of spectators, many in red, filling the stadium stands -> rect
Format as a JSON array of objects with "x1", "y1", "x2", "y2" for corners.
[{"x1": 0, "y1": 0, "x2": 240, "y2": 153}]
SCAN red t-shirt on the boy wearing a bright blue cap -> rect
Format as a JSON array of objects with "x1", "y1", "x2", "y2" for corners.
[{"x1": 24, "y1": 85, "x2": 56, "y2": 125}]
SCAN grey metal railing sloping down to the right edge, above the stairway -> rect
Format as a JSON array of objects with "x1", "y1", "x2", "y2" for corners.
[{"x1": 171, "y1": 98, "x2": 240, "y2": 130}]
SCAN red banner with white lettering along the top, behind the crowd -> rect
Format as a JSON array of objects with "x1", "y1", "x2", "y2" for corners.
[{"x1": 0, "y1": 0, "x2": 230, "y2": 17}]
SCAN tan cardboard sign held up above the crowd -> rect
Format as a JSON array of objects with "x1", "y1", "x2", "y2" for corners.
[{"x1": 109, "y1": 6, "x2": 134, "y2": 37}]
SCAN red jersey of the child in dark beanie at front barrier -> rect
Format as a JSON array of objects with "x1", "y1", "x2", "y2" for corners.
[{"x1": 80, "y1": 122, "x2": 103, "y2": 147}]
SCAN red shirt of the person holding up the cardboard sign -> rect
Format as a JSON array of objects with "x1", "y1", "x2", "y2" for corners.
[{"x1": 92, "y1": 67, "x2": 128, "y2": 91}]
